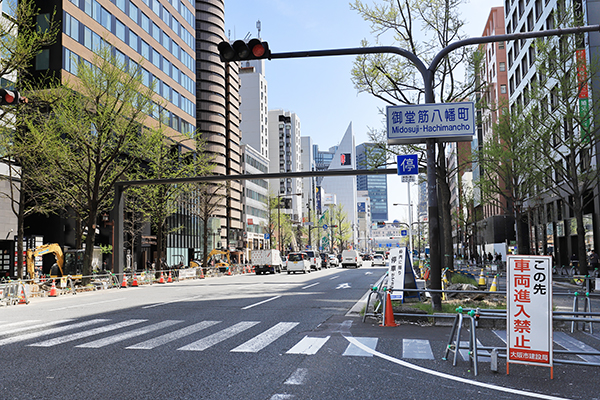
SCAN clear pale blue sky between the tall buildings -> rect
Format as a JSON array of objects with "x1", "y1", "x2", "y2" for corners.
[{"x1": 225, "y1": 0, "x2": 503, "y2": 221}]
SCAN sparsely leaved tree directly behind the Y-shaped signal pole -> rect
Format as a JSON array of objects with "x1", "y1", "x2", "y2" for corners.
[{"x1": 351, "y1": 0, "x2": 486, "y2": 309}]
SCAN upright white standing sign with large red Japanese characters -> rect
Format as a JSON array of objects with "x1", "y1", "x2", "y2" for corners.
[{"x1": 506, "y1": 255, "x2": 552, "y2": 367}]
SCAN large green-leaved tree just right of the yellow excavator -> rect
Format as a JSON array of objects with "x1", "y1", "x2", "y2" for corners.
[{"x1": 26, "y1": 42, "x2": 155, "y2": 282}]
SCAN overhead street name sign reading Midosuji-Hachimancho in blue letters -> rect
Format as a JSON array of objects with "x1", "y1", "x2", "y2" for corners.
[{"x1": 387, "y1": 102, "x2": 475, "y2": 144}]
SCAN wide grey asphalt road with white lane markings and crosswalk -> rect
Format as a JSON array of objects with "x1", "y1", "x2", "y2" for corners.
[{"x1": 0, "y1": 266, "x2": 600, "y2": 400}]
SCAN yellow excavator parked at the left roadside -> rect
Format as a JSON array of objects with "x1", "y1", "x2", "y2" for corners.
[{"x1": 26, "y1": 243, "x2": 84, "y2": 279}]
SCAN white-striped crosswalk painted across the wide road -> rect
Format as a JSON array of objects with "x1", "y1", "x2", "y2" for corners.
[{"x1": 0, "y1": 318, "x2": 600, "y2": 363}]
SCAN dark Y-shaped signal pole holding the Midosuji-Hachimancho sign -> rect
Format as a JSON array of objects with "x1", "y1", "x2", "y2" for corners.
[{"x1": 240, "y1": 25, "x2": 600, "y2": 311}]
